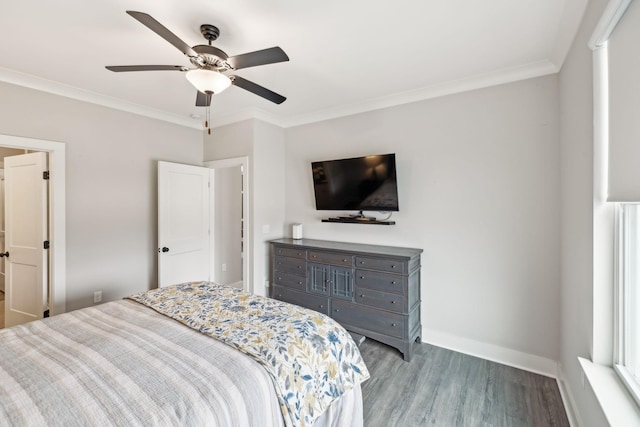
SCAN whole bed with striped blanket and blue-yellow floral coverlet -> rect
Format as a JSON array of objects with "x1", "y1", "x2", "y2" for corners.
[{"x1": 0, "y1": 282, "x2": 369, "y2": 427}]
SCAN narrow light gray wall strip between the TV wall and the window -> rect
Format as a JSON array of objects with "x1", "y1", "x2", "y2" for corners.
[{"x1": 559, "y1": 0, "x2": 608, "y2": 427}]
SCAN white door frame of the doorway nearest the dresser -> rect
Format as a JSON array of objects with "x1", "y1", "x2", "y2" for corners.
[{"x1": 208, "y1": 156, "x2": 253, "y2": 293}]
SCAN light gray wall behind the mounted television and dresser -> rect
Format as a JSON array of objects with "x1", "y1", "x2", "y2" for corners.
[{"x1": 286, "y1": 76, "x2": 560, "y2": 374}]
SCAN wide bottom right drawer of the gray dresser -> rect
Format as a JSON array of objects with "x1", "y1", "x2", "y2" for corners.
[{"x1": 331, "y1": 300, "x2": 408, "y2": 339}]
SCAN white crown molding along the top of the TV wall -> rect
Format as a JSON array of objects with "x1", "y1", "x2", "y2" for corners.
[{"x1": 281, "y1": 60, "x2": 559, "y2": 128}]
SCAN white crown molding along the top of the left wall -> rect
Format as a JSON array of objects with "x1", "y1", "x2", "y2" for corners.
[{"x1": 0, "y1": 67, "x2": 202, "y2": 129}]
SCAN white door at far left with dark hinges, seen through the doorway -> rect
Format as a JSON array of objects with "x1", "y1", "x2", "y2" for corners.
[{"x1": 2, "y1": 153, "x2": 49, "y2": 327}]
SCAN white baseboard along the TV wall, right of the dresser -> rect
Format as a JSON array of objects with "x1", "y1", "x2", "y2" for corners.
[{"x1": 422, "y1": 329, "x2": 558, "y2": 379}]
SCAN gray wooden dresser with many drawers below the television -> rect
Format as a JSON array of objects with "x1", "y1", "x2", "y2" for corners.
[{"x1": 270, "y1": 239, "x2": 422, "y2": 361}]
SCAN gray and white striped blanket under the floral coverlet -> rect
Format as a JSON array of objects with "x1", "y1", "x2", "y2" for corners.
[{"x1": 0, "y1": 284, "x2": 362, "y2": 427}]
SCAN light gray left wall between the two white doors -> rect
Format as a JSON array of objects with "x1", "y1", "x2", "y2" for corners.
[{"x1": 0, "y1": 83, "x2": 202, "y2": 310}]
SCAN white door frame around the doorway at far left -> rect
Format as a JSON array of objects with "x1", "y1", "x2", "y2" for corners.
[{"x1": 0, "y1": 134, "x2": 67, "y2": 315}]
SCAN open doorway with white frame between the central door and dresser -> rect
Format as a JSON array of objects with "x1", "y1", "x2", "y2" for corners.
[{"x1": 205, "y1": 157, "x2": 253, "y2": 292}]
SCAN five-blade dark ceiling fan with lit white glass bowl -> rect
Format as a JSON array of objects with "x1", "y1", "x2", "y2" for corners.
[{"x1": 105, "y1": 10, "x2": 289, "y2": 107}]
